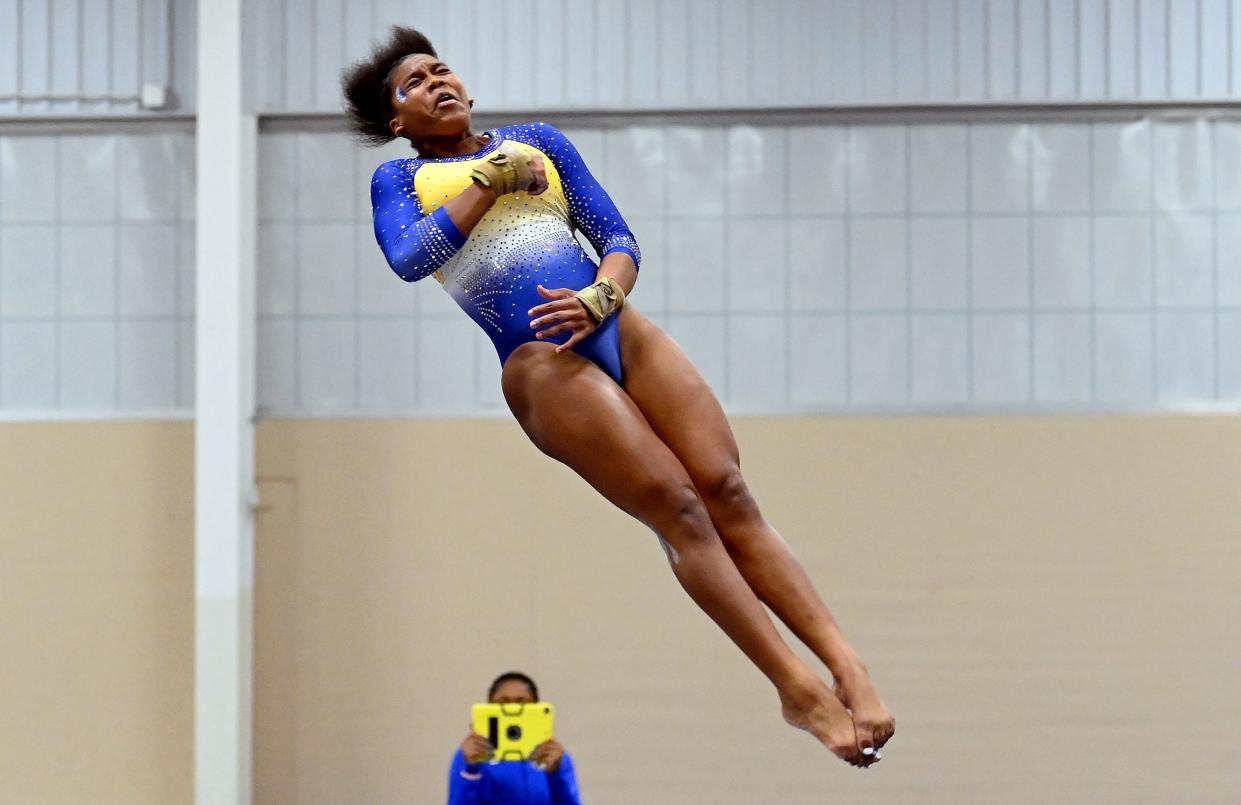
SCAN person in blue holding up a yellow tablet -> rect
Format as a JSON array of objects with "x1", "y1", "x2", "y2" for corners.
[{"x1": 448, "y1": 671, "x2": 582, "y2": 805}]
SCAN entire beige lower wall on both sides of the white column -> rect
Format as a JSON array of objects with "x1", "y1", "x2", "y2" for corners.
[{"x1": 0, "y1": 417, "x2": 1241, "y2": 805}]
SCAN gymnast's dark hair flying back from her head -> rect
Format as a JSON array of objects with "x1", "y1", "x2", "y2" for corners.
[{"x1": 340, "y1": 25, "x2": 438, "y2": 145}]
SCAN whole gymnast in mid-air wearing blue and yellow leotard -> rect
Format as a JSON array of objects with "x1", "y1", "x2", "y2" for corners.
[{"x1": 343, "y1": 27, "x2": 895, "y2": 767}]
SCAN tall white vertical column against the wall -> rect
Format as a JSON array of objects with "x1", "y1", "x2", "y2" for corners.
[{"x1": 194, "y1": 0, "x2": 257, "y2": 805}]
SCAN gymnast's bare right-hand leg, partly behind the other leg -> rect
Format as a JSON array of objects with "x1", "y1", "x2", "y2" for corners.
[{"x1": 621, "y1": 308, "x2": 896, "y2": 749}]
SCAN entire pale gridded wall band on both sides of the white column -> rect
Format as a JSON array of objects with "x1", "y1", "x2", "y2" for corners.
[{"x1": 0, "y1": 106, "x2": 1241, "y2": 416}]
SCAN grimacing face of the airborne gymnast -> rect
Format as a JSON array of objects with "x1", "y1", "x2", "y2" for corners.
[{"x1": 388, "y1": 53, "x2": 470, "y2": 141}]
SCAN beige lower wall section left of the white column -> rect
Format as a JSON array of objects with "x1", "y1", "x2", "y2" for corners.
[{"x1": 0, "y1": 422, "x2": 194, "y2": 805}]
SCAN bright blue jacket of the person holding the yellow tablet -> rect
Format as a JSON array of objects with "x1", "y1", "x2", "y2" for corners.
[{"x1": 448, "y1": 749, "x2": 582, "y2": 805}]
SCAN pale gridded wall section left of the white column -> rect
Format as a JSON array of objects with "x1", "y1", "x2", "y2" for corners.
[{"x1": 0, "y1": 131, "x2": 194, "y2": 417}]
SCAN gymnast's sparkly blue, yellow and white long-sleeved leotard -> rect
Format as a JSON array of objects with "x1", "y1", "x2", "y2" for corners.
[{"x1": 371, "y1": 123, "x2": 642, "y2": 383}]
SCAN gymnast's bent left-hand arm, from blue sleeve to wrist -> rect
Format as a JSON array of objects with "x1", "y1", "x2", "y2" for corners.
[{"x1": 371, "y1": 160, "x2": 496, "y2": 283}]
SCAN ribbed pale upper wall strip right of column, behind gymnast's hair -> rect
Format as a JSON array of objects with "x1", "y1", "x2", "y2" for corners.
[{"x1": 247, "y1": 0, "x2": 1241, "y2": 113}]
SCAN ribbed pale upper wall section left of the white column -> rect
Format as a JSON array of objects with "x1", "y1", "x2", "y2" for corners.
[{"x1": 0, "y1": 0, "x2": 197, "y2": 117}]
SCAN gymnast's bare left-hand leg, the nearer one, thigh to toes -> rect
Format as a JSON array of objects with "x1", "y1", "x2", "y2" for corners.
[{"x1": 503, "y1": 342, "x2": 872, "y2": 765}]
